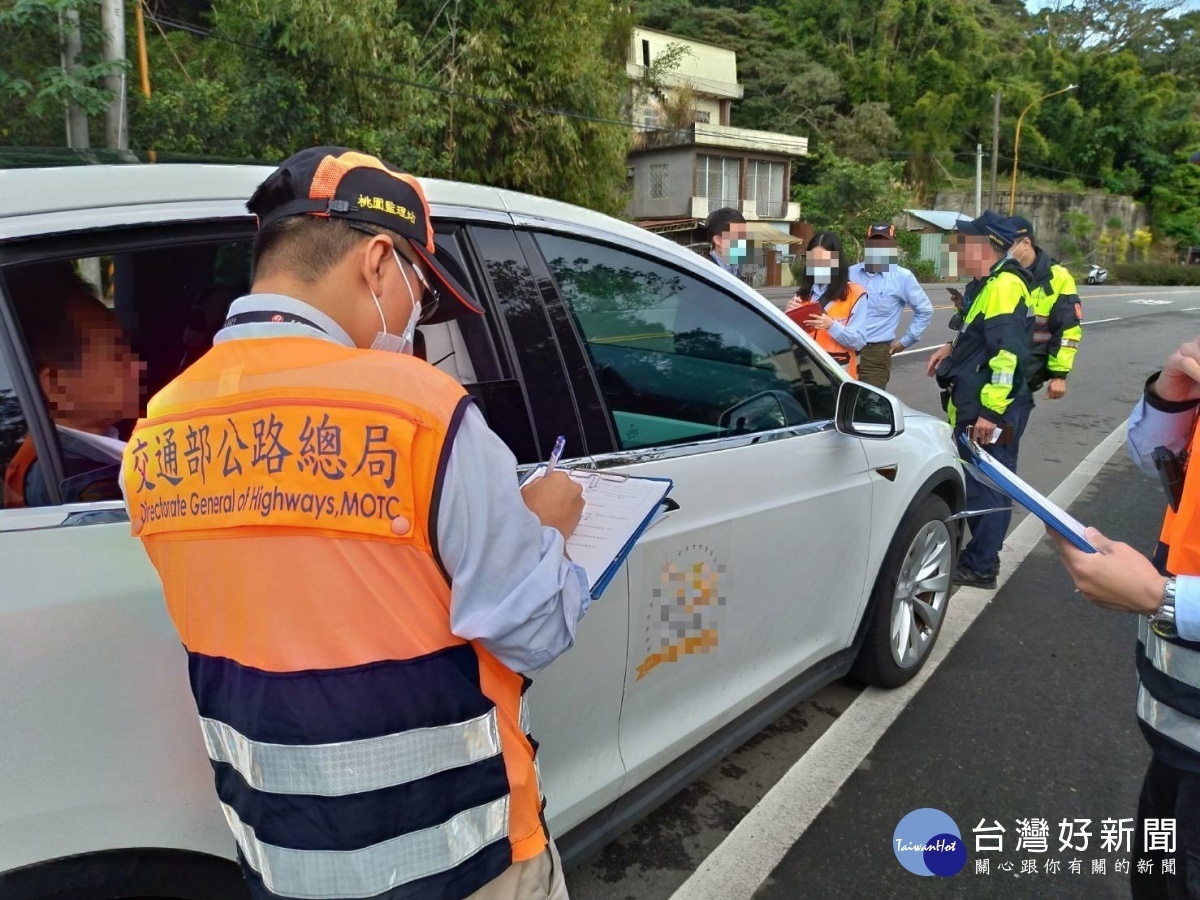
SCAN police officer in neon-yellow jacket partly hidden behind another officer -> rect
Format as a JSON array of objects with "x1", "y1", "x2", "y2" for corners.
[{"x1": 1009, "y1": 216, "x2": 1084, "y2": 400}]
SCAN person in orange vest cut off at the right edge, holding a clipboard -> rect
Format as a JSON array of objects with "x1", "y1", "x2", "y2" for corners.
[{"x1": 1050, "y1": 338, "x2": 1200, "y2": 900}]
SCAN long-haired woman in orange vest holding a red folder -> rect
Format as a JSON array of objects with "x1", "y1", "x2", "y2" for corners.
[{"x1": 787, "y1": 232, "x2": 866, "y2": 378}]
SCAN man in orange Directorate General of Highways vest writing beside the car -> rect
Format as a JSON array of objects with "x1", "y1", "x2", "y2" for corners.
[{"x1": 122, "y1": 148, "x2": 589, "y2": 900}]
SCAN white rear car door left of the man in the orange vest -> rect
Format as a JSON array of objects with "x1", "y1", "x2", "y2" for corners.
[{"x1": 0, "y1": 229, "x2": 244, "y2": 878}]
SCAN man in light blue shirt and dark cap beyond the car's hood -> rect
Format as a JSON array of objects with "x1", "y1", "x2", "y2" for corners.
[{"x1": 850, "y1": 222, "x2": 934, "y2": 390}]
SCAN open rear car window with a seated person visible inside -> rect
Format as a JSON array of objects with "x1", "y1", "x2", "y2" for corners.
[{"x1": 0, "y1": 234, "x2": 250, "y2": 508}]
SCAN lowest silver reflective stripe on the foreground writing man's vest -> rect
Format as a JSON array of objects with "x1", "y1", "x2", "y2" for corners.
[{"x1": 221, "y1": 796, "x2": 509, "y2": 900}]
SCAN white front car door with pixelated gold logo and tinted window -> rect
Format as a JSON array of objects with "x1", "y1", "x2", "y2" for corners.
[{"x1": 523, "y1": 229, "x2": 871, "y2": 786}]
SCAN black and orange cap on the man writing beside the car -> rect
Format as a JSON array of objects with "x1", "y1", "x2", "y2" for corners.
[{"x1": 258, "y1": 146, "x2": 484, "y2": 322}]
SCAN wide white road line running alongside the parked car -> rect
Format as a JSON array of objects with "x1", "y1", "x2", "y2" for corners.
[{"x1": 672, "y1": 422, "x2": 1128, "y2": 900}]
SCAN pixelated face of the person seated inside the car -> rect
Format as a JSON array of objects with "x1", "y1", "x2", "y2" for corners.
[{"x1": 41, "y1": 296, "x2": 145, "y2": 432}]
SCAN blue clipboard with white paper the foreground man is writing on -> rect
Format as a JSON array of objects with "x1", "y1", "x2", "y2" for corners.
[{"x1": 521, "y1": 466, "x2": 679, "y2": 600}]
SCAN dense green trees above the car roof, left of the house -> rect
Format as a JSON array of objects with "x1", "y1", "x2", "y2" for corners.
[{"x1": 131, "y1": 0, "x2": 630, "y2": 214}]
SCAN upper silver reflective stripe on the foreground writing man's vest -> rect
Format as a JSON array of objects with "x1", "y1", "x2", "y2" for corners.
[{"x1": 200, "y1": 708, "x2": 500, "y2": 797}]
